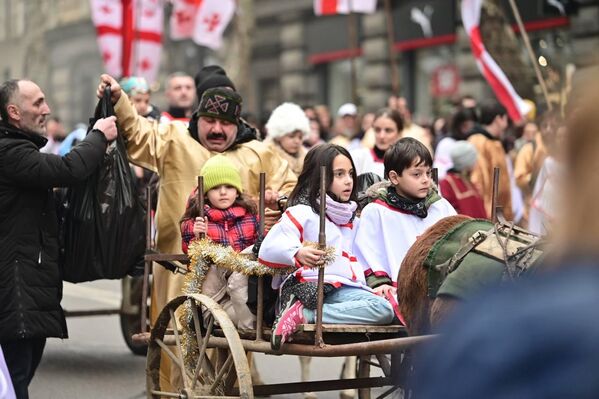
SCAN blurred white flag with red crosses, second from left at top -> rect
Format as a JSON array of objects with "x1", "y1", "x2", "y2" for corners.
[{"x1": 171, "y1": 0, "x2": 236, "y2": 49}]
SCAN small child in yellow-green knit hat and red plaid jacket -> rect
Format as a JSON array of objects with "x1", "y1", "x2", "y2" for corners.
[{"x1": 181, "y1": 155, "x2": 258, "y2": 329}]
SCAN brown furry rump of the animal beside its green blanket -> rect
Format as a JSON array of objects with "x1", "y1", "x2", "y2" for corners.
[{"x1": 397, "y1": 215, "x2": 471, "y2": 335}]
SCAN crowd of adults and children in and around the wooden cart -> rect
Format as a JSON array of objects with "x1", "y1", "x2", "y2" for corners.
[{"x1": 0, "y1": 66, "x2": 566, "y2": 398}]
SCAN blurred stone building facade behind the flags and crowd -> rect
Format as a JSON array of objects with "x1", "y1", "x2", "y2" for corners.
[{"x1": 0, "y1": 0, "x2": 599, "y2": 127}]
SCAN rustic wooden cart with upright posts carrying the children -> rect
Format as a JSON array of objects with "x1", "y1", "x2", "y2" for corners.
[{"x1": 135, "y1": 173, "x2": 431, "y2": 398}]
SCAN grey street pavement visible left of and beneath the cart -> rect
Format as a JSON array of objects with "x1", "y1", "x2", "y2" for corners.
[{"x1": 29, "y1": 281, "x2": 390, "y2": 399}]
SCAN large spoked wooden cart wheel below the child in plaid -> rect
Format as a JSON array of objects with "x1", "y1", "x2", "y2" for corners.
[{"x1": 146, "y1": 294, "x2": 254, "y2": 399}]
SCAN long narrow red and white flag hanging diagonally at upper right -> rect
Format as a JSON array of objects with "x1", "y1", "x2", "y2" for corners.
[{"x1": 462, "y1": 0, "x2": 530, "y2": 123}]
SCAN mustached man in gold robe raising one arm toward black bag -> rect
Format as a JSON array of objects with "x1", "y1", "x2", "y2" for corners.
[{"x1": 97, "y1": 69, "x2": 297, "y2": 386}]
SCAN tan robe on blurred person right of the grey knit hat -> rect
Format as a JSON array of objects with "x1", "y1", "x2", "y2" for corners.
[{"x1": 468, "y1": 134, "x2": 514, "y2": 220}]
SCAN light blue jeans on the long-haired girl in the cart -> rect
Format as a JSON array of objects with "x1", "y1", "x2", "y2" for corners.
[{"x1": 304, "y1": 285, "x2": 395, "y2": 324}]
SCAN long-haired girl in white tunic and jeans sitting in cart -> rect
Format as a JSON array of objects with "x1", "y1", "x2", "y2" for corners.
[{"x1": 258, "y1": 144, "x2": 394, "y2": 349}]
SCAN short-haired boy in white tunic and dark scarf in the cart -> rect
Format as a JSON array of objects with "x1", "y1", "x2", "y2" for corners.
[{"x1": 354, "y1": 137, "x2": 456, "y2": 298}]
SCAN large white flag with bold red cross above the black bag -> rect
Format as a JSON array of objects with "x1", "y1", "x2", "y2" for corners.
[{"x1": 91, "y1": 0, "x2": 164, "y2": 82}]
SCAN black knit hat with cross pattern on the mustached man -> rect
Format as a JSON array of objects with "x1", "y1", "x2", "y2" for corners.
[{"x1": 196, "y1": 88, "x2": 242, "y2": 125}]
